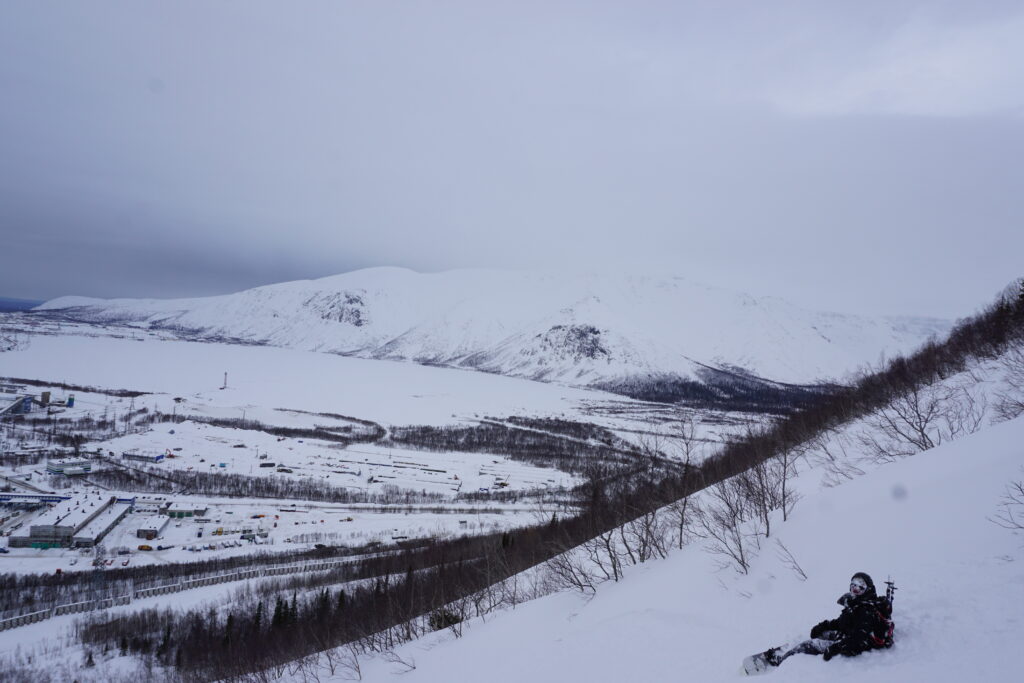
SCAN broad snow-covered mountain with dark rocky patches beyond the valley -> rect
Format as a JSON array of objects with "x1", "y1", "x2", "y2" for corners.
[{"x1": 36, "y1": 268, "x2": 949, "y2": 401}]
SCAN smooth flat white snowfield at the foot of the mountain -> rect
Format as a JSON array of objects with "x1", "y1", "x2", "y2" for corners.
[{"x1": 0, "y1": 327, "x2": 622, "y2": 425}]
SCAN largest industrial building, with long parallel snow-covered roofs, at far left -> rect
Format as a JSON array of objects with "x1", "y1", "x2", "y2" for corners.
[{"x1": 8, "y1": 494, "x2": 132, "y2": 548}]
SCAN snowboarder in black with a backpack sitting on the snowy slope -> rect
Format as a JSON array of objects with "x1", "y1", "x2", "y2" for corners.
[{"x1": 764, "y1": 571, "x2": 892, "y2": 667}]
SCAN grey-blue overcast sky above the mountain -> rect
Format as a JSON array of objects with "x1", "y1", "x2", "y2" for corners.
[{"x1": 0, "y1": 0, "x2": 1024, "y2": 317}]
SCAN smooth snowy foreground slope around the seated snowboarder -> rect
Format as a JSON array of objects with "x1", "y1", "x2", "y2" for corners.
[{"x1": 350, "y1": 418, "x2": 1024, "y2": 683}]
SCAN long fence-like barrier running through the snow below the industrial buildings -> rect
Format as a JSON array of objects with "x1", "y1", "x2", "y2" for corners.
[{"x1": 0, "y1": 559, "x2": 352, "y2": 631}]
